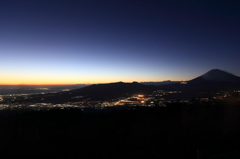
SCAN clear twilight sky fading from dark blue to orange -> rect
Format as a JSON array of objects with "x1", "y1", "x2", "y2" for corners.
[{"x1": 0, "y1": 0, "x2": 240, "y2": 84}]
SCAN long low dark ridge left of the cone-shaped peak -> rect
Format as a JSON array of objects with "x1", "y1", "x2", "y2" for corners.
[{"x1": 24, "y1": 82, "x2": 157, "y2": 103}]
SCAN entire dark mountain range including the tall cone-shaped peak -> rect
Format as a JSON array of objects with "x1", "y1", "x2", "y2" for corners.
[{"x1": 18, "y1": 69, "x2": 240, "y2": 102}]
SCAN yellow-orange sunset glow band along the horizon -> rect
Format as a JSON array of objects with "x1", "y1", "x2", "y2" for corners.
[{"x1": 0, "y1": 73, "x2": 188, "y2": 85}]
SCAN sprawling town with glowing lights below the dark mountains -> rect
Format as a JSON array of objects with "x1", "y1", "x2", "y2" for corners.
[{"x1": 0, "y1": 90, "x2": 240, "y2": 110}]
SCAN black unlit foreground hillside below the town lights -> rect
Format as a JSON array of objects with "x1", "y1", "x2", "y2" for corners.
[{"x1": 0, "y1": 99, "x2": 240, "y2": 159}]
